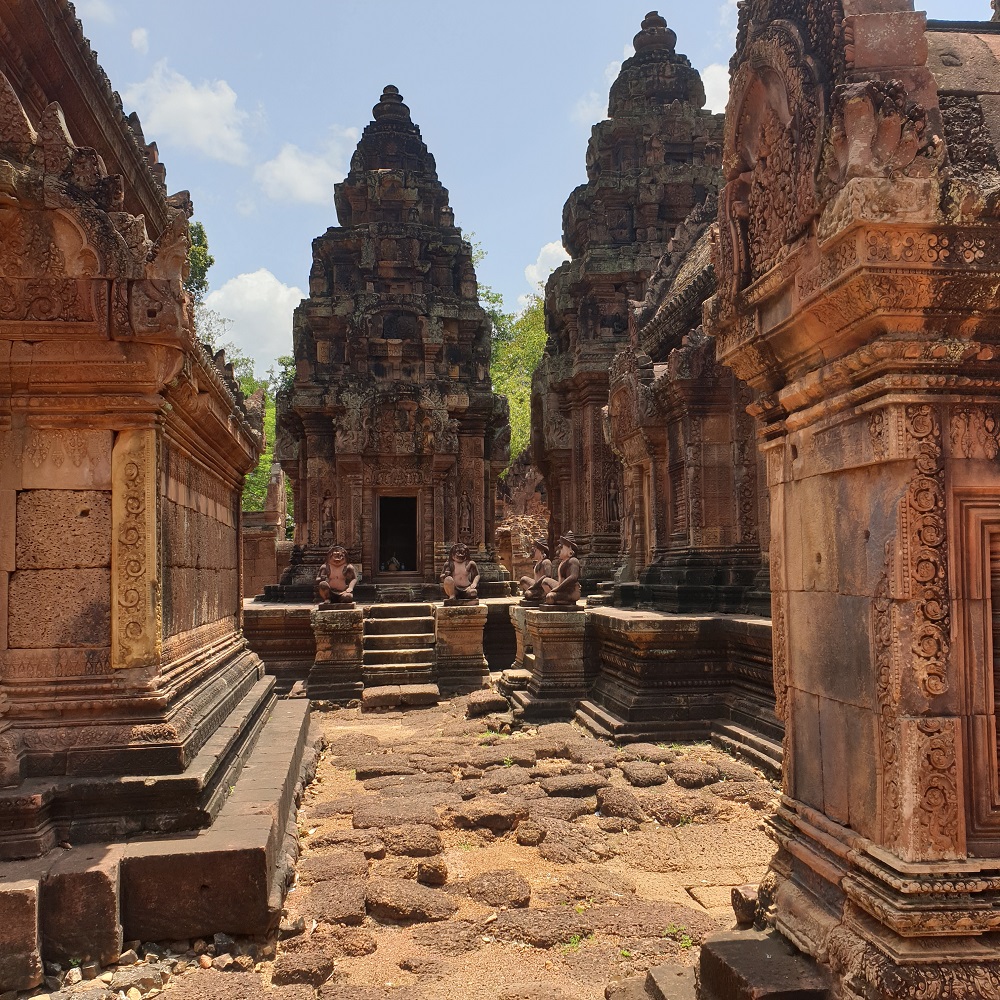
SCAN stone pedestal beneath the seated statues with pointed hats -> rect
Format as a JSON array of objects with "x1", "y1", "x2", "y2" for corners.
[{"x1": 511, "y1": 608, "x2": 593, "y2": 719}]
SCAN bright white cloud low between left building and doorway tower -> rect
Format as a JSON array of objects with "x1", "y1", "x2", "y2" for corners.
[{"x1": 205, "y1": 267, "x2": 303, "y2": 378}]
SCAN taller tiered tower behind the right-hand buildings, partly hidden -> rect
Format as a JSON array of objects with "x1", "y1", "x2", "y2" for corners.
[{"x1": 531, "y1": 13, "x2": 722, "y2": 586}]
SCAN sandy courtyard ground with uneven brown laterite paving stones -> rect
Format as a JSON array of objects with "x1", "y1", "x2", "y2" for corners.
[{"x1": 88, "y1": 698, "x2": 777, "y2": 1000}]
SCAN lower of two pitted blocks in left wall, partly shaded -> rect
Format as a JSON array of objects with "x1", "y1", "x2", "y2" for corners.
[{"x1": 7, "y1": 569, "x2": 111, "y2": 649}]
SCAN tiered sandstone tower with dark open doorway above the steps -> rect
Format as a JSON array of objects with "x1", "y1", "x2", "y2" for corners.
[{"x1": 269, "y1": 87, "x2": 510, "y2": 599}]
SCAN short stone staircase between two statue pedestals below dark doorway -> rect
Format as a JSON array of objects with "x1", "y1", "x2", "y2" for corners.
[{"x1": 361, "y1": 603, "x2": 439, "y2": 710}]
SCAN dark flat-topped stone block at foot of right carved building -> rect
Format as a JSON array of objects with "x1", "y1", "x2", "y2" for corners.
[{"x1": 698, "y1": 930, "x2": 828, "y2": 1000}]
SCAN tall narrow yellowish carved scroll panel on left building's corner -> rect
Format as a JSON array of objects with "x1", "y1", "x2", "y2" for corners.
[{"x1": 111, "y1": 429, "x2": 160, "y2": 670}]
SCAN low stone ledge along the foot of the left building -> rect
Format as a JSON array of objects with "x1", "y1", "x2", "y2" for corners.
[{"x1": 0, "y1": 700, "x2": 316, "y2": 991}]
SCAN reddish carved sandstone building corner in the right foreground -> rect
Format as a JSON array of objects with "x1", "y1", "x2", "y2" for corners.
[{"x1": 706, "y1": 0, "x2": 1000, "y2": 1000}]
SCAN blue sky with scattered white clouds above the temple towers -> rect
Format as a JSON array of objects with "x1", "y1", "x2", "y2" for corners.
[{"x1": 77, "y1": 0, "x2": 990, "y2": 372}]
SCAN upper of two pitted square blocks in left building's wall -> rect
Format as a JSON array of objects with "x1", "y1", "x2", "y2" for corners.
[{"x1": 17, "y1": 490, "x2": 111, "y2": 569}]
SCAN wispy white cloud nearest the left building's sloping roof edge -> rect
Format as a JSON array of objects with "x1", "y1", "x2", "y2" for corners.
[{"x1": 123, "y1": 59, "x2": 249, "y2": 165}]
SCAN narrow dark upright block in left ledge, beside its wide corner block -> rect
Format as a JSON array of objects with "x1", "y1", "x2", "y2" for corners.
[{"x1": 41, "y1": 845, "x2": 124, "y2": 966}]
